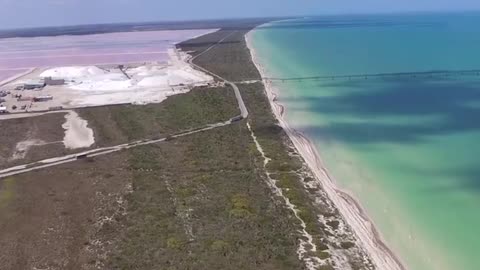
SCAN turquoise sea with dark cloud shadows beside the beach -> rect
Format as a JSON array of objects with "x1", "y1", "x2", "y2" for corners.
[{"x1": 251, "y1": 13, "x2": 480, "y2": 270}]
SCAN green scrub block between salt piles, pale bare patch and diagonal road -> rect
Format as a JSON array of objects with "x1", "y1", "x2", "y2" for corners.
[{"x1": 78, "y1": 87, "x2": 239, "y2": 146}]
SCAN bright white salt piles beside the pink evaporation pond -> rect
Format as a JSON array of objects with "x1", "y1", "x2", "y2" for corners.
[{"x1": 33, "y1": 50, "x2": 214, "y2": 107}]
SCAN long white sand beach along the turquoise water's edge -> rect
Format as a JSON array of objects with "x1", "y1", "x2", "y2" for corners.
[{"x1": 245, "y1": 30, "x2": 406, "y2": 270}]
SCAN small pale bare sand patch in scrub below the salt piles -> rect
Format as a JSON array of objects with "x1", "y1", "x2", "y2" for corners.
[{"x1": 62, "y1": 111, "x2": 95, "y2": 149}]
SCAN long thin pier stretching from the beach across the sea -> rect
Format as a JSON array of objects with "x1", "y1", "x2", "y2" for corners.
[{"x1": 262, "y1": 69, "x2": 480, "y2": 82}]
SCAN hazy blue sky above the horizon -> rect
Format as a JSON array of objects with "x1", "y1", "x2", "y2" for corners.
[{"x1": 0, "y1": 0, "x2": 480, "y2": 29}]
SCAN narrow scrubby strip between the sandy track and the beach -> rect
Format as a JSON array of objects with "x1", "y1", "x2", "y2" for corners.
[{"x1": 183, "y1": 24, "x2": 386, "y2": 269}]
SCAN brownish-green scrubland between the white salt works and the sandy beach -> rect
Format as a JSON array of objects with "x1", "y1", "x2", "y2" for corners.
[{"x1": 0, "y1": 20, "x2": 402, "y2": 270}]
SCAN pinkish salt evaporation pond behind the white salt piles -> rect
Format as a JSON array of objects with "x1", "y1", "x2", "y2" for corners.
[{"x1": 0, "y1": 29, "x2": 216, "y2": 77}]
